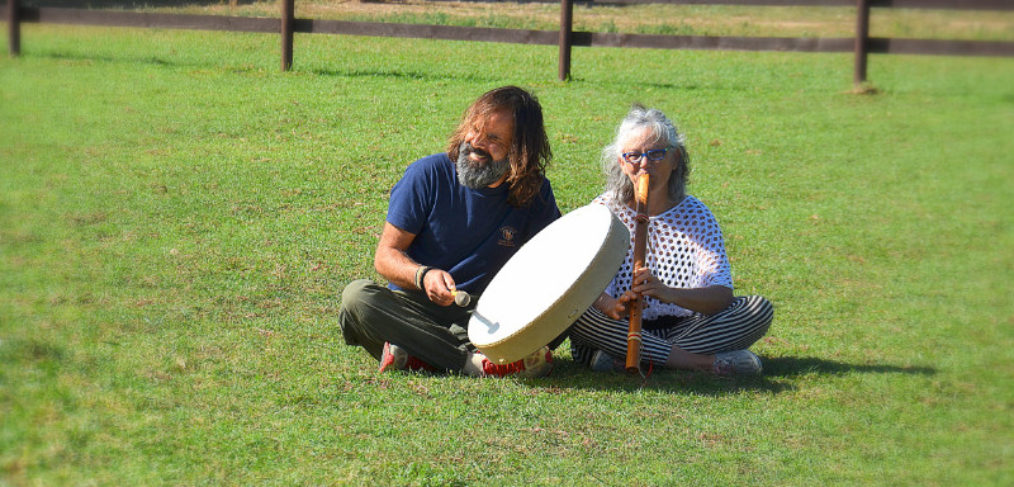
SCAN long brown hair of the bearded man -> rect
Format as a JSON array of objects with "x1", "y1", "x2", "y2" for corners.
[{"x1": 447, "y1": 86, "x2": 553, "y2": 207}]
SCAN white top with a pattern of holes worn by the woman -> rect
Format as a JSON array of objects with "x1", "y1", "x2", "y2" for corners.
[{"x1": 592, "y1": 192, "x2": 732, "y2": 320}]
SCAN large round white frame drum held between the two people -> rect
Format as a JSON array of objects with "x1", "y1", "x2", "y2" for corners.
[{"x1": 468, "y1": 204, "x2": 630, "y2": 363}]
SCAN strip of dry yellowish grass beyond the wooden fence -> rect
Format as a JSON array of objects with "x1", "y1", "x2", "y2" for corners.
[{"x1": 140, "y1": 0, "x2": 1014, "y2": 41}]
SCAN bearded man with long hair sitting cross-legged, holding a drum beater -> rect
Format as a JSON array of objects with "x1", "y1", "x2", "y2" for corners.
[{"x1": 339, "y1": 86, "x2": 560, "y2": 376}]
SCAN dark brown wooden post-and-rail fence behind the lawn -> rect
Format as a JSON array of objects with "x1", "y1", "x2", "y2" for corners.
[{"x1": 5, "y1": 0, "x2": 1014, "y2": 84}]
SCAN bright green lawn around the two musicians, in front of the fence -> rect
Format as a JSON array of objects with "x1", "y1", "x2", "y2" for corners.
[{"x1": 0, "y1": 25, "x2": 1014, "y2": 486}]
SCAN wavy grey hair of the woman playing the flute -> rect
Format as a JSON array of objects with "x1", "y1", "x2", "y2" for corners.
[{"x1": 602, "y1": 103, "x2": 691, "y2": 202}]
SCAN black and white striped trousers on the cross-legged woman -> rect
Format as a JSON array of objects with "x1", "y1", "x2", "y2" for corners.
[{"x1": 569, "y1": 296, "x2": 775, "y2": 365}]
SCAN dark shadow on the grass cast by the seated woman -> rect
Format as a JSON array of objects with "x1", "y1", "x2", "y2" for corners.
[{"x1": 532, "y1": 357, "x2": 937, "y2": 396}]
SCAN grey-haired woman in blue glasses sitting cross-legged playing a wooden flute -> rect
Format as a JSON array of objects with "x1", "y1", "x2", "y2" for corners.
[{"x1": 570, "y1": 106, "x2": 774, "y2": 375}]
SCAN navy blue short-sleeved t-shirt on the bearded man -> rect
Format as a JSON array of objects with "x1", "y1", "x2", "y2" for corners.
[{"x1": 387, "y1": 154, "x2": 560, "y2": 294}]
